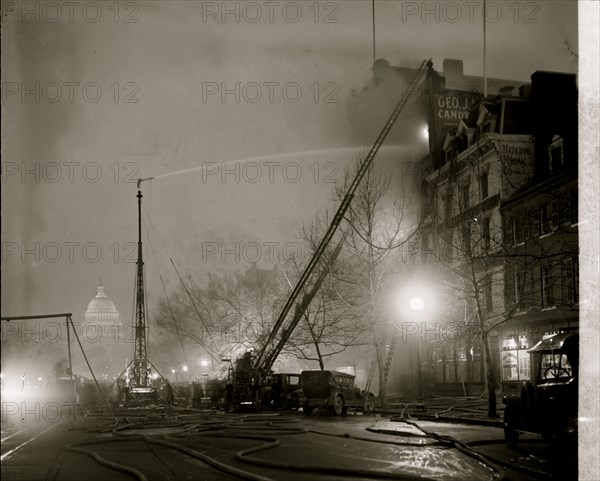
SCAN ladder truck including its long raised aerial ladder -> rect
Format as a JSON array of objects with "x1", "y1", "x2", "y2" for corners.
[{"x1": 225, "y1": 59, "x2": 433, "y2": 411}]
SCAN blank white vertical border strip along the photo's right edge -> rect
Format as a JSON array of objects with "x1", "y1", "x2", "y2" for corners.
[{"x1": 578, "y1": 0, "x2": 600, "y2": 481}]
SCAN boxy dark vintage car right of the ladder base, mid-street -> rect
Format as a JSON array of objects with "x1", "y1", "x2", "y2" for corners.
[{"x1": 300, "y1": 371, "x2": 375, "y2": 416}]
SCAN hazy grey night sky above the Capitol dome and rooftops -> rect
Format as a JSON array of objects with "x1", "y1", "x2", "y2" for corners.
[{"x1": 2, "y1": 0, "x2": 578, "y2": 321}]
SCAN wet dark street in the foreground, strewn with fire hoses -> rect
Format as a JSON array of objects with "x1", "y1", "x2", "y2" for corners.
[{"x1": 2, "y1": 409, "x2": 577, "y2": 481}]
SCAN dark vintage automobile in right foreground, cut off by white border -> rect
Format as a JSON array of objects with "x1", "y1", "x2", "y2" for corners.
[{"x1": 502, "y1": 331, "x2": 579, "y2": 447}]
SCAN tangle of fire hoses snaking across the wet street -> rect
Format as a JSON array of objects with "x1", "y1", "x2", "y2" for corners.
[{"x1": 47, "y1": 409, "x2": 524, "y2": 481}]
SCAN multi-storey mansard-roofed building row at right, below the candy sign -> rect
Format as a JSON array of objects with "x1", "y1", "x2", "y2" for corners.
[{"x1": 421, "y1": 72, "x2": 578, "y2": 394}]
